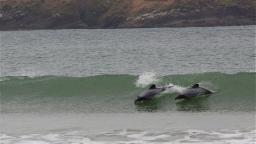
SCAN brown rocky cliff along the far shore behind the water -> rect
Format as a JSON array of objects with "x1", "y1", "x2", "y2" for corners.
[{"x1": 0, "y1": 0, "x2": 256, "y2": 30}]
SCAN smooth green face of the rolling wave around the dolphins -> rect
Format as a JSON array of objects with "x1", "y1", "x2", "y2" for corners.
[{"x1": 0, "y1": 73, "x2": 256, "y2": 112}]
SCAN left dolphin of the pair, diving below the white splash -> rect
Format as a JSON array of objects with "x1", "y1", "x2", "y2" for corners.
[{"x1": 135, "y1": 84, "x2": 168, "y2": 102}]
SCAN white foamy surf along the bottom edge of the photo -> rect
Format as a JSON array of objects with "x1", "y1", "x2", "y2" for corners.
[{"x1": 0, "y1": 129, "x2": 256, "y2": 144}]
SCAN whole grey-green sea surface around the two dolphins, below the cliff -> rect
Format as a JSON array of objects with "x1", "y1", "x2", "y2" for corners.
[{"x1": 0, "y1": 26, "x2": 256, "y2": 144}]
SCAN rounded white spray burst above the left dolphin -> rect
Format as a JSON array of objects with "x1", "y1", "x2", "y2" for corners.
[{"x1": 136, "y1": 72, "x2": 160, "y2": 88}]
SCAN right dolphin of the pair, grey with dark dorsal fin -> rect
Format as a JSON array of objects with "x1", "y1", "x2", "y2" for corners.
[{"x1": 175, "y1": 84, "x2": 215, "y2": 100}]
